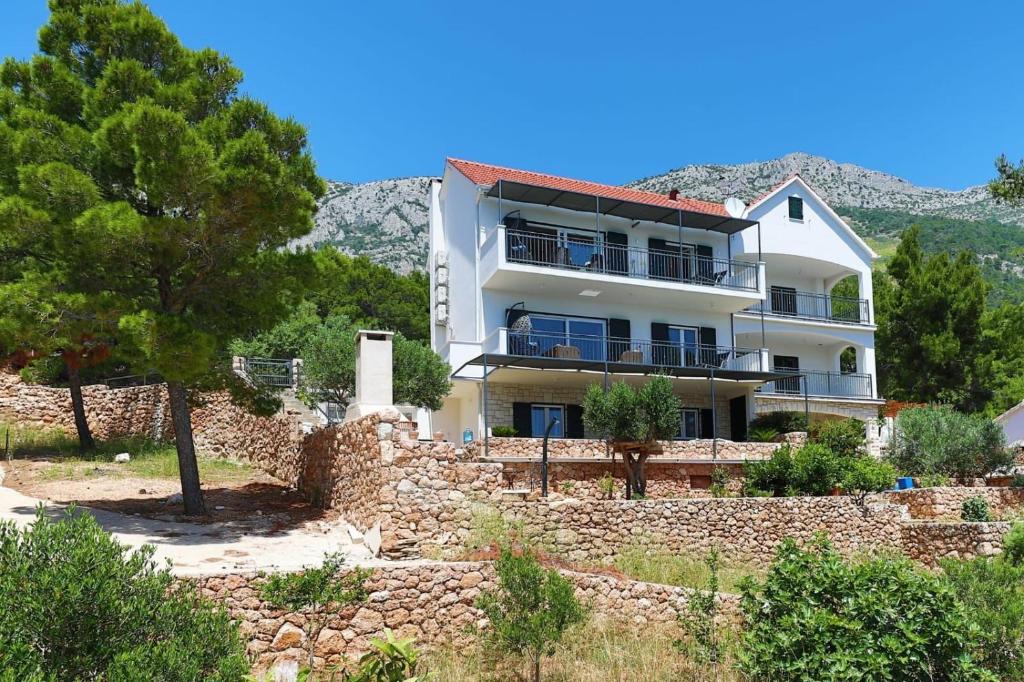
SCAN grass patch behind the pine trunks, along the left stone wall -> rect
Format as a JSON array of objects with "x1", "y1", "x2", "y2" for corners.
[{"x1": 0, "y1": 424, "x2": 253, "y2": 483}]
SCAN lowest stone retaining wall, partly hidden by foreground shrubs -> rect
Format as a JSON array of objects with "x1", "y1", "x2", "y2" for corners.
[{"x1": 197, "y1": 562, "x2": 738, "y2": 669}]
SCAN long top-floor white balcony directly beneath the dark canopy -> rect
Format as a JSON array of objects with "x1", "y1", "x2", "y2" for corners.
[{"x1": 480, "y1": 224, "x2": 765, "y2": 313}]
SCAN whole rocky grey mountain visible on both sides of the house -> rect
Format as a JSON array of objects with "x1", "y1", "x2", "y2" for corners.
[{"x1": 295, "y1": 154, "x2": 1024, "y2": 280}]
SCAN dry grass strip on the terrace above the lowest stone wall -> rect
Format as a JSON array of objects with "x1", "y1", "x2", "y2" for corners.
[{"x1": 614, "y1": 546, "x2": 761, "y2": 593}]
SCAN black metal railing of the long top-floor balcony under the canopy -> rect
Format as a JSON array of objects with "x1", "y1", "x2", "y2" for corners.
[{"x1": 505, "y1": 228, "x2": 759, "y2": 292}]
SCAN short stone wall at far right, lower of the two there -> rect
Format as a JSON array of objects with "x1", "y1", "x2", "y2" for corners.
[{"x1": 901, "y1": 521, "x2": 1012, "y2": 566}]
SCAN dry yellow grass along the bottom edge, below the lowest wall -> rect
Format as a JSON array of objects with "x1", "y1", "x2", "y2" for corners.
[{"x1": 424, "y1": 616, "x2": 740, "y2": 682}]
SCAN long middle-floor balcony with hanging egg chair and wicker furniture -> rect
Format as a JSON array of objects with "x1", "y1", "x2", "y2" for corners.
[{"x1": 482, "y1": 327, "x2": 778, "y2": 378}]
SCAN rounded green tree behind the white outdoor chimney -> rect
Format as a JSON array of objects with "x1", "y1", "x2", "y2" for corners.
[{"x1": 300, "y1": 315, "x2": 452, "y2": 410}]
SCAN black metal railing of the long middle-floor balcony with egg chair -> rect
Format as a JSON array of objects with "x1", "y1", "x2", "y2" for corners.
[{"x1": 483, "y1": 327, "x2": 765, "y2": 372}]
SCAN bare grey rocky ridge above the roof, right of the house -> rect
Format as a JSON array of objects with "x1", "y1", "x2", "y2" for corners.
[{"x1": 629, "y1": 153, "x2": 1024, "y2": 225}]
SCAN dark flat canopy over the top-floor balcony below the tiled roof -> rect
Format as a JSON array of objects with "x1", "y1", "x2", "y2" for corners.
[{"x1": 487, "y1": 180, "x2": 757, "y2": 235}]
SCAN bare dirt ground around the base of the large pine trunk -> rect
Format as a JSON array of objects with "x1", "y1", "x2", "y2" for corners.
[{"x1": 3, "y1": 458, "x2": 338, "y2": 534}]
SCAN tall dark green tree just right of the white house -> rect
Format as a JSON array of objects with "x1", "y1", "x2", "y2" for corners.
[{"x1": 874, "y1": 225, "x2": 989, "y2": 411}]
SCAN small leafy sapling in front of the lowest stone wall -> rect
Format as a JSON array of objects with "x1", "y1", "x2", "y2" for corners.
[{"x1": 476, "y1": 547, "x2": 586, "y2": 682}]
